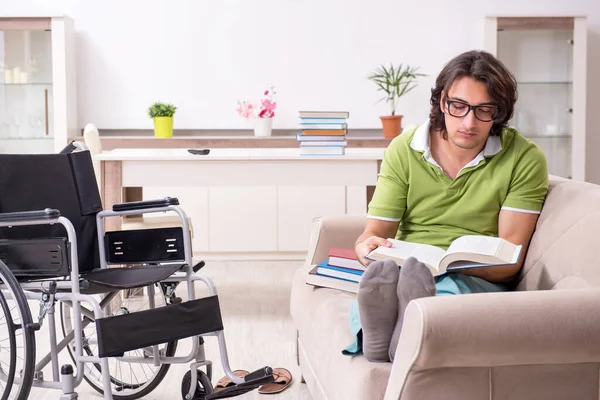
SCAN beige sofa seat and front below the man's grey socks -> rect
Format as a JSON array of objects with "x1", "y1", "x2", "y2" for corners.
[{"x1": 291, "y1": 266, "x2": 392, "y2": 400}]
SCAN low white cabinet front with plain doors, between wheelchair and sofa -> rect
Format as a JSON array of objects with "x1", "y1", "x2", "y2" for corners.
[{"x1": 143, "y1": 186, "x2": 358, "y2": 254}]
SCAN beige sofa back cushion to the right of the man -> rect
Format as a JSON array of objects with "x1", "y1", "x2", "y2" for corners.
[{"x1": 517, "y1": 180, "x2": 600, "y2": 290}]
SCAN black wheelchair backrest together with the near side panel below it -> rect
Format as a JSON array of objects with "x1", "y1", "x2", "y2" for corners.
[{"x1": 0, "y1": 151, "x2": 102, "y2": 279}]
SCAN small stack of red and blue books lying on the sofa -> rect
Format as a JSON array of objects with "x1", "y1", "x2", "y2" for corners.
[{"x1": 306, "y1": 248, "x2": 366, "y2": 293}]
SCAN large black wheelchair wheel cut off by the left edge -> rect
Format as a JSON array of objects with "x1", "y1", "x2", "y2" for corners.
[{"x1": 0, "y1": 261, "x2": 35, "y2": 400}]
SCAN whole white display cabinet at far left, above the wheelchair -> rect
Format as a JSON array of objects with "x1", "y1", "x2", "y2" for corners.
[{"x1": 0, "y1": 16, "x2": 78, "y2": 153}]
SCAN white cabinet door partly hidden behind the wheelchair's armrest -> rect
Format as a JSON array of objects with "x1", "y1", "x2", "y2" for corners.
[{"x1": 143, "y1": 187, "x2": 208, "y2": 252}]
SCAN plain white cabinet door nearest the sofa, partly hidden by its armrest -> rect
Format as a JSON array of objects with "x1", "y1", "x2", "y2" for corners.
[{"x1": 277, "y1": 186, "x2": 346, "y2": 251}]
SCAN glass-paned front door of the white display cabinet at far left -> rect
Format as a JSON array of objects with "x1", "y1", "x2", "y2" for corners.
[{"x1": 0, "y1": 18, "x2": 55, "y2": 154}]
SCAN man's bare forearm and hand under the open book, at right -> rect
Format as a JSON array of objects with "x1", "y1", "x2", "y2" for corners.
[{"x1": 461, "y1": 210, "x2": 539, "y2": 282}]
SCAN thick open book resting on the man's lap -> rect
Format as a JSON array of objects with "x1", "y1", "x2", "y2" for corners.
[{"x1": 366, "y1": 235, "x2": 523, "y2": 276}]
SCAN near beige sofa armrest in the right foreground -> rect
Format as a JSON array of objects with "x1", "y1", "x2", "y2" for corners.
[{"x1": 385, "y1": 289, "x2": 600, "y2": 399}]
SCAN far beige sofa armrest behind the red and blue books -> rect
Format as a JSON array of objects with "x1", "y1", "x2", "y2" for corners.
[{"x1": 306, "y1": 214, "x2": 367, "y2": 265}]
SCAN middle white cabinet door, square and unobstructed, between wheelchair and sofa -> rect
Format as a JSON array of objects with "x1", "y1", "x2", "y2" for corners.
[{"x1": 208, "y1": 186, "x2": 277, "y2": 252}]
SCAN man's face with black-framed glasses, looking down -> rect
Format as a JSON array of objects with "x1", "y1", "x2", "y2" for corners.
[{"x1": 440, "y1": 77, "x2": 496, "y2": 150}]
